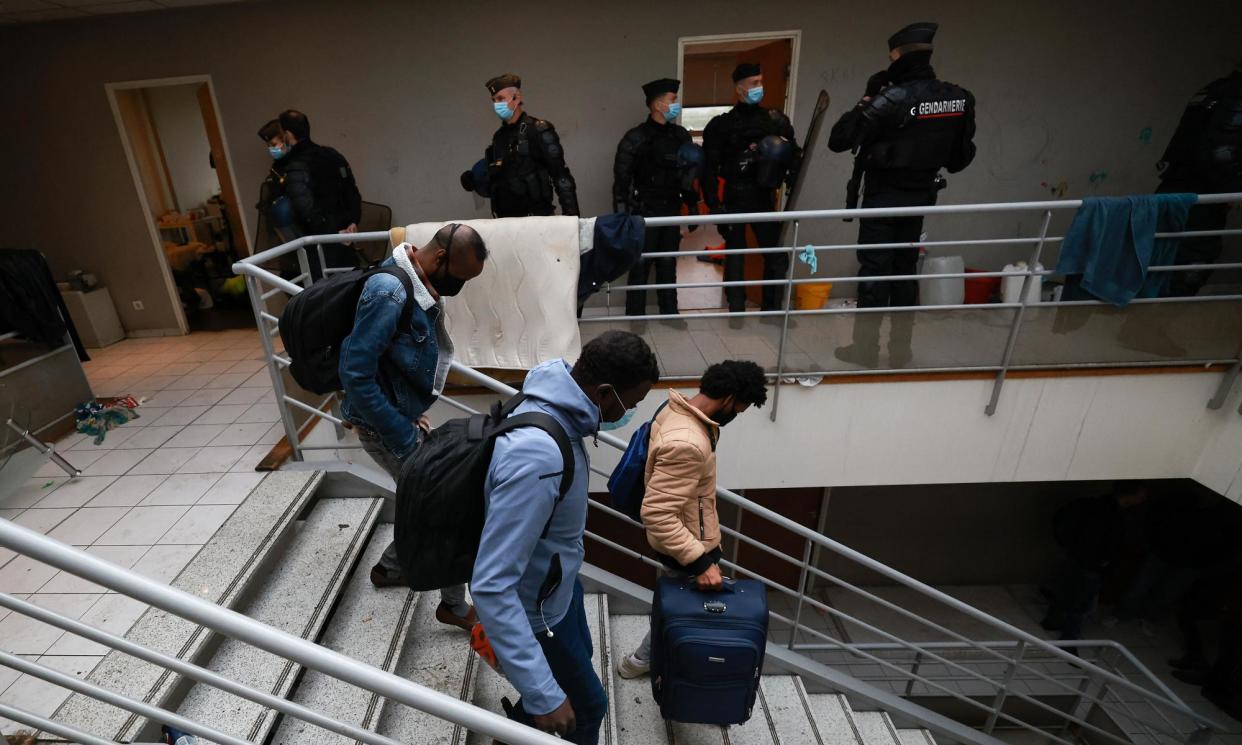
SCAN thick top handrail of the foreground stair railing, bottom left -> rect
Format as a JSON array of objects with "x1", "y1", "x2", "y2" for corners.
[{"x1": 0, "y1": 519, "x2": 560, "y2": 745}]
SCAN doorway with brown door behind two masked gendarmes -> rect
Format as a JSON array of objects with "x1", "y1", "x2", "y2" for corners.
[{"x1": 677, "y1": 31, "x2": 802, "y2": 310}]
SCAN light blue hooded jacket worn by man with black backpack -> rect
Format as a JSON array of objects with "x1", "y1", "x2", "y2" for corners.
[{"x1": 471, "y1": 360, "x2": 600, "y2": 715}]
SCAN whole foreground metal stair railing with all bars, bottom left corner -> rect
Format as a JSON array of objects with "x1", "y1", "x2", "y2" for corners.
[{"x1": 0, "y1": 519, "x2": 561, "y2": 745}]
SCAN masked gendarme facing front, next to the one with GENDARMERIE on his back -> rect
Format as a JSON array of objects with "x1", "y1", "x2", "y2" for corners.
[{"x1": 703, "y1": 63, "x2": 802, "y2": 313}]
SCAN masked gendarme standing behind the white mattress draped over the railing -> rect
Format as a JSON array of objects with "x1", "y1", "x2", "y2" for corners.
[{"x1": 487, "y1": 75, "x2": 579, "y2": 217}]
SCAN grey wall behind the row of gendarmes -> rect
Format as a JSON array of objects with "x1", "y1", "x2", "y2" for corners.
[{"x1": 0, "y1": 0, "x2": 1242, "y2": 329}]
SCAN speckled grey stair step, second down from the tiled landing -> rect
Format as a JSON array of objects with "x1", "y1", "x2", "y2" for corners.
[{"x1": 178, "y1": 498, "x2": 383, "y2": 743}]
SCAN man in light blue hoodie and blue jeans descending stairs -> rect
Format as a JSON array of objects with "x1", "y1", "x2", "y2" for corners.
[{"x1": 471, "y1": 332, "x2": 660, "y2": 745}]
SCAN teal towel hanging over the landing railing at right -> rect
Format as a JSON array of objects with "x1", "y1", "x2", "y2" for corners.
[{"x1": 1057, "y1": 194, "x2": 1199, "y2": 308}]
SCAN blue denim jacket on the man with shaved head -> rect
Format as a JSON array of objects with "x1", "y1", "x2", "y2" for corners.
[{"x1": 339, "y1": 258, "x2": 442, "y2": 458}]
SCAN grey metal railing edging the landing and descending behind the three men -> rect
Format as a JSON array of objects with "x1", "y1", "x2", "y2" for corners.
[{"x1": 226, "y1": 194, "x2": 1242, "y2": 743}]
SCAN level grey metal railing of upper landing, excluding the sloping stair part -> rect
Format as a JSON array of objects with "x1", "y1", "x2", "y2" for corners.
[{"x1": 232, "y1": 194, "x2": 1242, "y2": 459}]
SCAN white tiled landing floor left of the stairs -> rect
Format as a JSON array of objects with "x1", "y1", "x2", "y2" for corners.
[{"x1": 0, "y1": 330, "x2": 276, "y2": 733}]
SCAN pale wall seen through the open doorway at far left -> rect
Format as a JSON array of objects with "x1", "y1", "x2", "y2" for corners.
[{"x1": 147, "y1": 84, "x2": 220, "y2": 212}]
